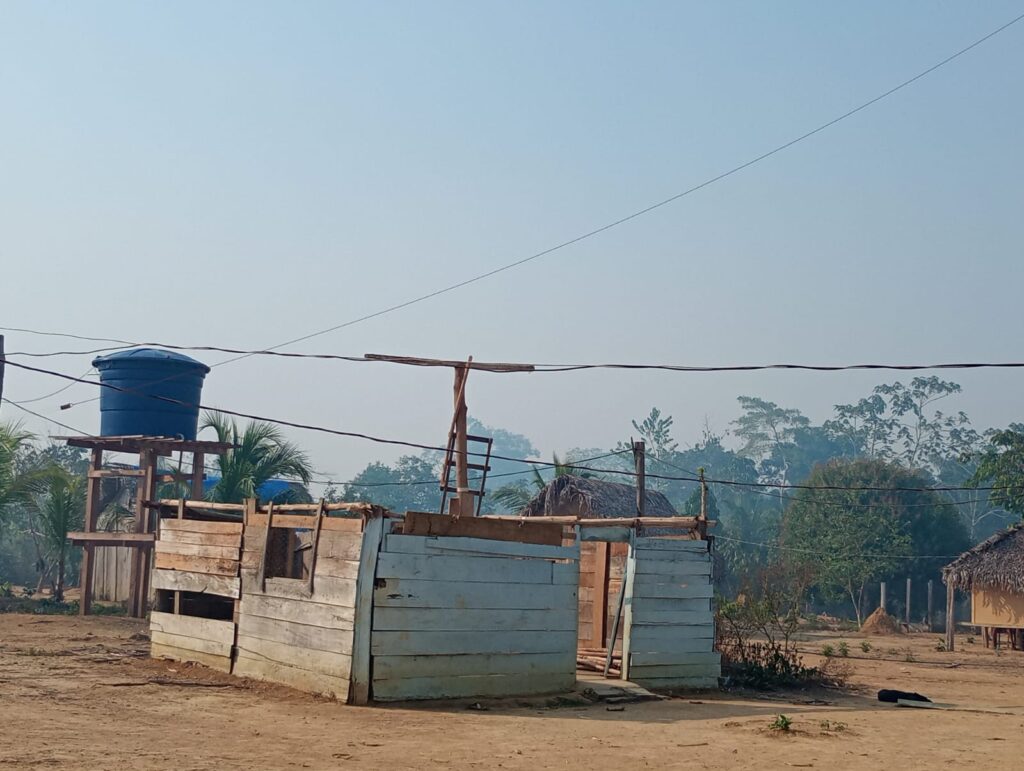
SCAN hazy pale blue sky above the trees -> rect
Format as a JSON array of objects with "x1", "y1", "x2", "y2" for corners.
[{"x1": 0, "y1": 0, "x2": 1024, "y2": 477}]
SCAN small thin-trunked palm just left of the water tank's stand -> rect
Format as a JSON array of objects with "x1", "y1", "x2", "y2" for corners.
[{"x1": 28, "y1": 466, "x2": 85, "y2": 602}]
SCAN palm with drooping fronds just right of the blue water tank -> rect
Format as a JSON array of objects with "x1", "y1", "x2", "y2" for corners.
[{"x1": 201, "y1": 413, "x2": 313, "y2": 503}]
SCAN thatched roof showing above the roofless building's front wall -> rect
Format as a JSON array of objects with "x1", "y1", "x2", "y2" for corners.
[{"x1": 522, "y1": 475, "x2": 679, "y2": 519}]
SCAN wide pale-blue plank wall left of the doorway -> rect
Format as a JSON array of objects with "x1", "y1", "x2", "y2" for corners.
[{"x1": 371, "y1": 533, "x2": 580, "y2": 701}]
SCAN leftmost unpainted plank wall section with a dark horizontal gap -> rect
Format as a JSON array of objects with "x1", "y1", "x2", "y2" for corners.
[{"x1": 150, "y1": 519, "x2": 242, "y2": 672}]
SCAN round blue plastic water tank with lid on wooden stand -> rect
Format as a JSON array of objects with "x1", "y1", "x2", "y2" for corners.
[{"x1": 92, "y1": 348, "x2": 210, "y2": 439}]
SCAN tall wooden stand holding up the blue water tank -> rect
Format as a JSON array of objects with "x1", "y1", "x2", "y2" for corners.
[{"x1": 64, "y1": 436, "x2": 231, "y2": 618}]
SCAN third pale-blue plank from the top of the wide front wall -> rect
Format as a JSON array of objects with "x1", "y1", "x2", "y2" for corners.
[{"x1": 374, "y1": 579, "x2": 578, "y2": 610}]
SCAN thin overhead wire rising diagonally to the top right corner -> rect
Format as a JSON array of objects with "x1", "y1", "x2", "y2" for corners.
[{"x1": 2, "y1": 13, "x2": 1024, "y2": 367}]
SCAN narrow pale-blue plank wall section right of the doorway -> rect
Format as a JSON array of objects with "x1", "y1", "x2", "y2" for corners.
[{"x1": 623, "y1": 538, "x2": 722, "y2": 688}]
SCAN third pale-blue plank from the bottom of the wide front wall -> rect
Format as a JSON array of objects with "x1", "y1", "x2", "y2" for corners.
[{"x1": 371, "y1": 632, "x2": 575, "y2": 656}]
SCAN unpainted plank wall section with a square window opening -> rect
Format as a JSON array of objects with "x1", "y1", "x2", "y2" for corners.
[{"x1": 234, "y1": 515, "x2": 362, "y2": 701}]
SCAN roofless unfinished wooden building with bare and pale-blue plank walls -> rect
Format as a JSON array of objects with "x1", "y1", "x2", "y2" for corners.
[{"x1": 152, "y1": 489, "x2": 719, "y2": 703}]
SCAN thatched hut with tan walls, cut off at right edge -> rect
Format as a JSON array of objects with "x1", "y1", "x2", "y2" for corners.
[{"x1": 942, "y1": 525, "x2": 1024, "y2": 650}]
